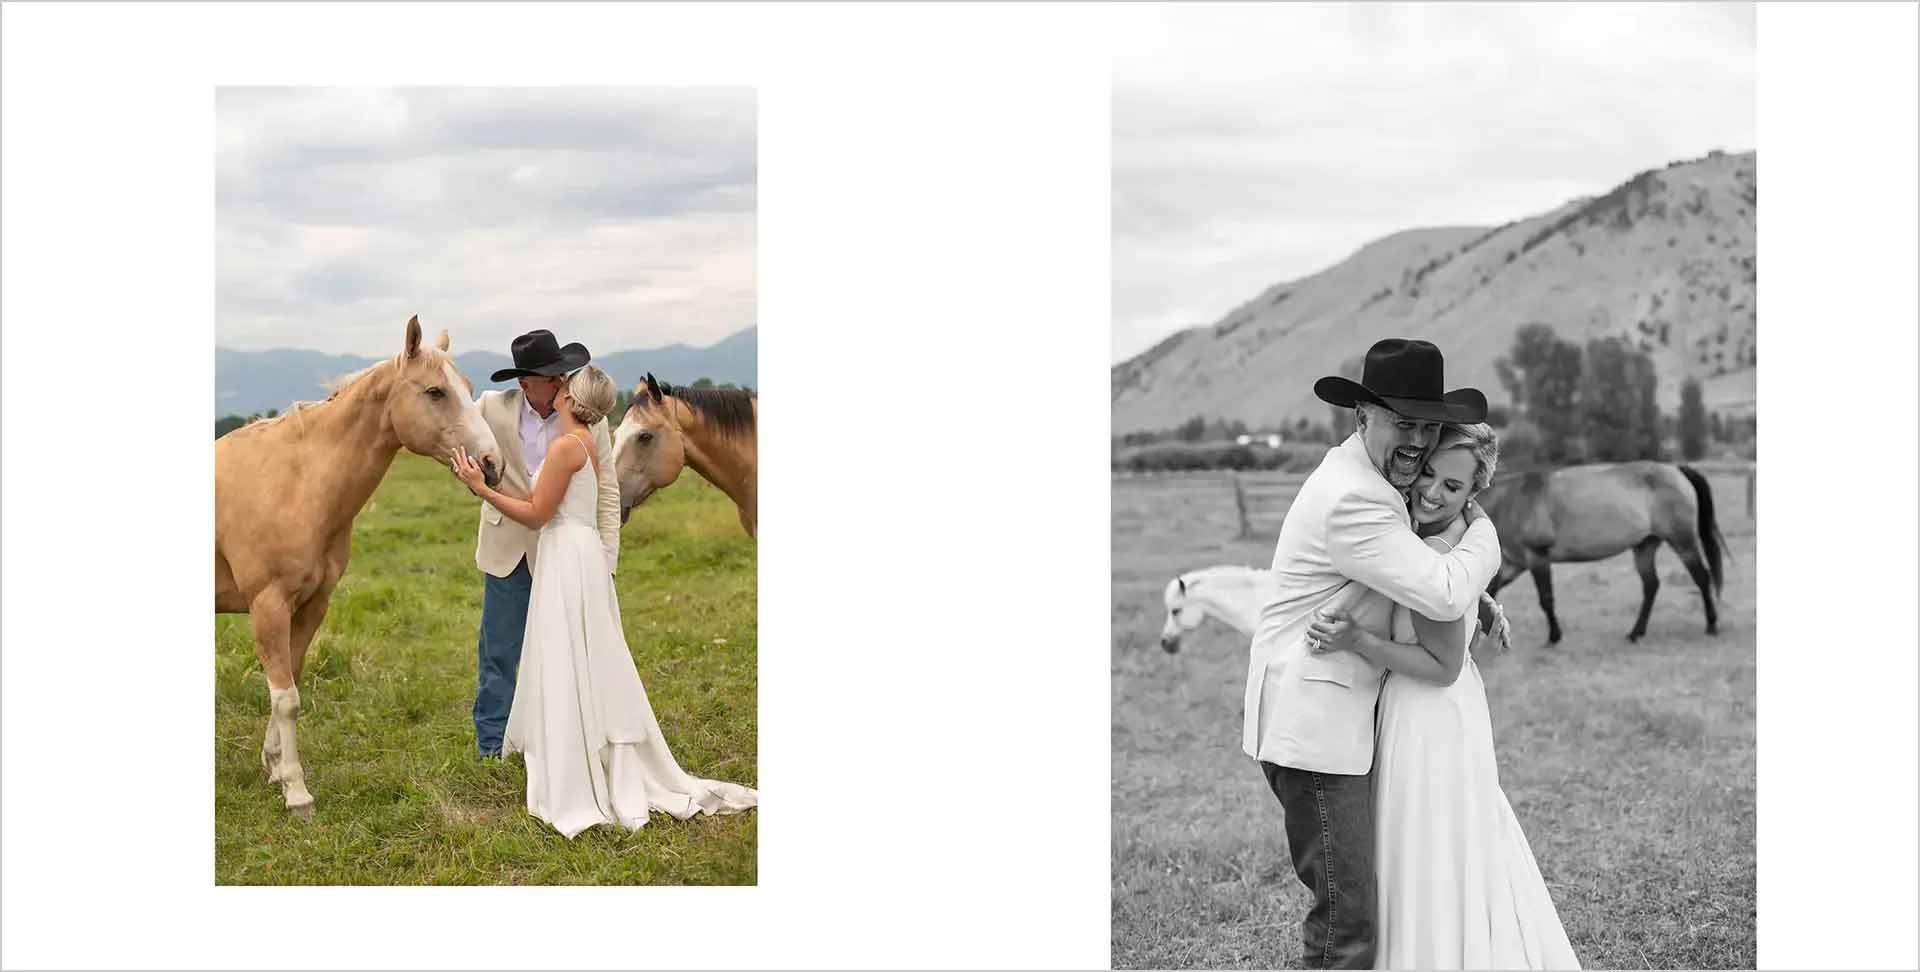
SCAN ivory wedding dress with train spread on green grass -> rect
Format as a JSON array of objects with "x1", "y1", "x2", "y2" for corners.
[{"x1": 505, "y1": 436, "x2": 760, "y2": 838}]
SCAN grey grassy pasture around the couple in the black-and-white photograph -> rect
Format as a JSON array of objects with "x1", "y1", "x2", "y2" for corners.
[{"x1": 1112, "y1": 465, "x2": 1757, "y2": 968}]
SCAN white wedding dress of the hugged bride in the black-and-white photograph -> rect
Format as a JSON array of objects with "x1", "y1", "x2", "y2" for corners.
[{"x1": 1373, "y1": 540, "x2": 1580, "y2": 968}]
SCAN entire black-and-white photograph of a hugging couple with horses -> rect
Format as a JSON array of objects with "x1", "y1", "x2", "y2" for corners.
[{"x1": 1112, "y1": 4, "x2": 1759, "y2": 968}]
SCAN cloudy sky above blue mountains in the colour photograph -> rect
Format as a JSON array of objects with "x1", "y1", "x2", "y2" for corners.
[{"x1": 215, "y1": 88, "x2": 756, "y2": 355}]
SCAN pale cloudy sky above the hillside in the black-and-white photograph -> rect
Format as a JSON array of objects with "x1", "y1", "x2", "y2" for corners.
[{"x1": 1112, "y1": 4, "x2": 1755, "y2": 361}]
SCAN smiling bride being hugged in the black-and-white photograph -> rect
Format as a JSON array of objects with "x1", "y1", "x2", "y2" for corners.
[{"x1": 1308, "y1": 423, "x2": 1580, "y2": 968}]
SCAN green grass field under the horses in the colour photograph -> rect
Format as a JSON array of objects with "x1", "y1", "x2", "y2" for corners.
[{"x1": 213, "y1": 453, "x2": 758, "y2": 884}]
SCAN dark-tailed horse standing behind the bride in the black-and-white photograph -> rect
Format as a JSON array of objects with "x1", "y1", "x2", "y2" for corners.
[{"x1": 1478, "y1": 461, "x2": 1726, "y2": 644}]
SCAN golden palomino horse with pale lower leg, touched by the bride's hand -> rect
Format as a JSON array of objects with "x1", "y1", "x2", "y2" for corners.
[{"x1": 213, "y1": 317, "x2": 499, "y2": 816}]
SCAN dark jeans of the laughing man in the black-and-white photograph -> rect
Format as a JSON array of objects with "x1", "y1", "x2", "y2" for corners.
[{"x1": 1260, "y1": 763, "x2": 1375, "y2": 968}]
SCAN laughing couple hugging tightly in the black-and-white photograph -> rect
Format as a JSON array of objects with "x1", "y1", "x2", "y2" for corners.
[{"x1": 1242, "y1": 338, "x2": 1578, "y2": 968}]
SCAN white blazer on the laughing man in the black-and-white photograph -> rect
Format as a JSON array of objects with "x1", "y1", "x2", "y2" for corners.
[{"x1": 1240, "y1": 432, "x2": 1500, "y2": 776}]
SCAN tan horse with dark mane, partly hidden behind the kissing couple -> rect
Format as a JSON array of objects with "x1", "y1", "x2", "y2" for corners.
[{"x1": 612, "y1": 375, "x2": 760, "y2": 536}]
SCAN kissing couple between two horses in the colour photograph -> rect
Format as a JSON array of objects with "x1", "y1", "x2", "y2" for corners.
[{"x1": 453, "y1": 330, "x2": 758, "y2": 838}]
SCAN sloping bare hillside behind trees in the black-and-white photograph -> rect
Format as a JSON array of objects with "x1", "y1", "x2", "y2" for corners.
[{"x1": 1112, "y1": 152, "x2": 1757, "y2": 436}]
